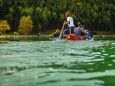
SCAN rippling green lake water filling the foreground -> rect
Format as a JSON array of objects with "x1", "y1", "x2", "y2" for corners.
[{"x1": 0, "y1": 40, "x2": 115, "y2": 86}]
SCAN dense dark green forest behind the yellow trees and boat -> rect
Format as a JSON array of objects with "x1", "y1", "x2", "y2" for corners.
[{"x1": 0, "y1": 0, "x2": 115, "y2": 33}]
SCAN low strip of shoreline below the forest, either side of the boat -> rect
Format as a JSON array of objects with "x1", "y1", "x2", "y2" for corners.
[{"x1": 0, "y1": 35, "x2": 115, "y2": 41}]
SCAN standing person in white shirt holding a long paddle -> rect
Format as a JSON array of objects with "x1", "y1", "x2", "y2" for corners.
[{"x1": 64, "y1": 12, "x2": 74, "y2": 35}]
